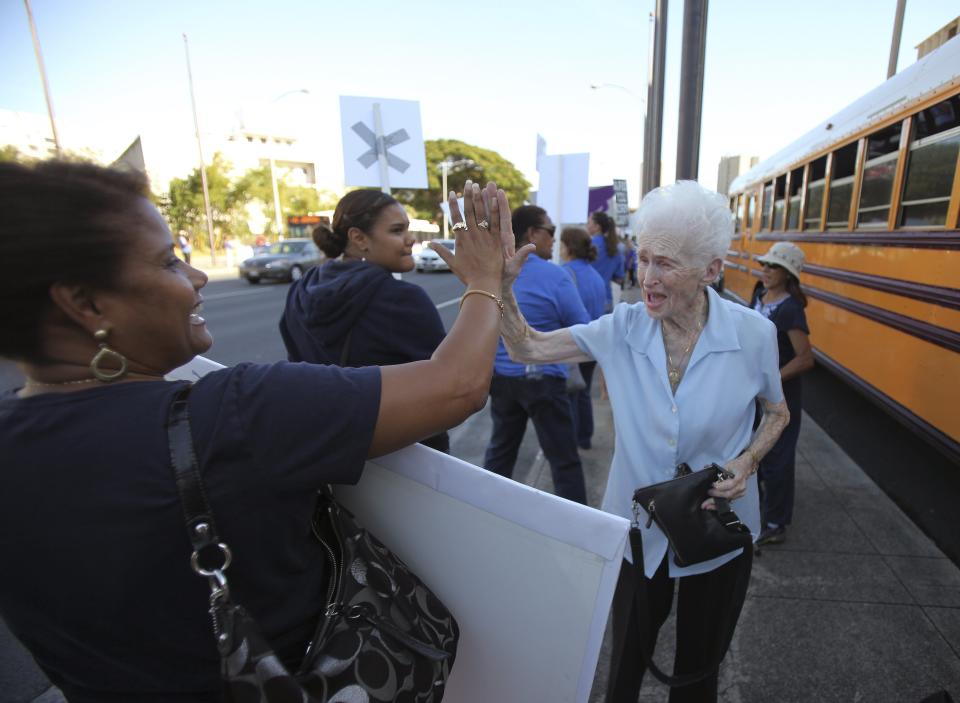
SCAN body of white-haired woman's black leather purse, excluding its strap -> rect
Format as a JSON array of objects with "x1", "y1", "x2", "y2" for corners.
[{"x1": 633, "y1": 464, "x2": 753, "y2": 566}]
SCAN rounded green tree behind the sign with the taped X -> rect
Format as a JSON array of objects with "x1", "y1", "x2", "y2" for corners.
[{"x1": 393, "y1": 139, "x2": 530, "y2": 220}]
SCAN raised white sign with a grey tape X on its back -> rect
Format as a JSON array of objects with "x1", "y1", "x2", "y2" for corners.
[{"x1": 340, "y1": 95, "x2": 427, "y2": 188}]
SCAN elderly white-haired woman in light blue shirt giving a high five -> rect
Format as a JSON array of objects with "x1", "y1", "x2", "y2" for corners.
[{"x1": 501, "y1": 181, "x2": 789, "y2": 703}]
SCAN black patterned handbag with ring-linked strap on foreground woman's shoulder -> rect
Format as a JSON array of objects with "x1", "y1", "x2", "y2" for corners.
[{"x1": 167, "y1": 386, "x2": 460, "y2": 703}]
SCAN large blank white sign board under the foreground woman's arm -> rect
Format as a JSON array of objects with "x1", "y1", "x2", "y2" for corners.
[{"x1": 168, "y1": 357, "x2": 630, "y2": 703}]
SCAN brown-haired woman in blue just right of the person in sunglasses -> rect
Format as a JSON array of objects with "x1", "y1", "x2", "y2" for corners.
[{"x1": 560, "y1": 227, "x2": 607, "y2": 449}]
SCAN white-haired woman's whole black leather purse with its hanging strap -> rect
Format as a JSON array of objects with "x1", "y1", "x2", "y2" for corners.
[{"x1": 610, "y1": 464, "x2": 753, "y2": 687}]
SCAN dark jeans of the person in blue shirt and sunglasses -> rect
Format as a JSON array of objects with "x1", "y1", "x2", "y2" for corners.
[{"x1": 483, "y1": 375, "x2": 587, "y2": 505}]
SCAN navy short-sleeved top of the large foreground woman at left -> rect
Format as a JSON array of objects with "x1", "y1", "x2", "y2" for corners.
[{"x1": 0, "y1": 362, "x2": 380, "y2": 703}]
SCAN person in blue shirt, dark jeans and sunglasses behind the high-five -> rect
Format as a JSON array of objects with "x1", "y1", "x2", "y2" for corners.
[{"x1": 483, "y1": 205, "x2": 590, "y2": 504}]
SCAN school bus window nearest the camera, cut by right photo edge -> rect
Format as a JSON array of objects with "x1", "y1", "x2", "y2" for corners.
[{"x1": 899, "y1": 95, "x2": 960, "y2": 227}]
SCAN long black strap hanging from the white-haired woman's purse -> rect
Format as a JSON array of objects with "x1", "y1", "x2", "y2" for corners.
[{"x1": 610, "y1": 511, "x2": 753, "y2": 688}]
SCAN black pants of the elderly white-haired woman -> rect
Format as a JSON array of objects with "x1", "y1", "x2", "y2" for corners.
[{"x1": 607, "y1": 556, "x2": 743, "y2": 703}]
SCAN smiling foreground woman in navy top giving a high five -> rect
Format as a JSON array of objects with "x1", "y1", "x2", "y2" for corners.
[{"x1": 0, "y1": 162, "x2": 513, "y2": 703}]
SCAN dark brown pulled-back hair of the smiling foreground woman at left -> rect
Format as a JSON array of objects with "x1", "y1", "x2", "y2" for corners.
[{"x1": 0, "y1": 161, "x2": 148, "y2": 360}]
